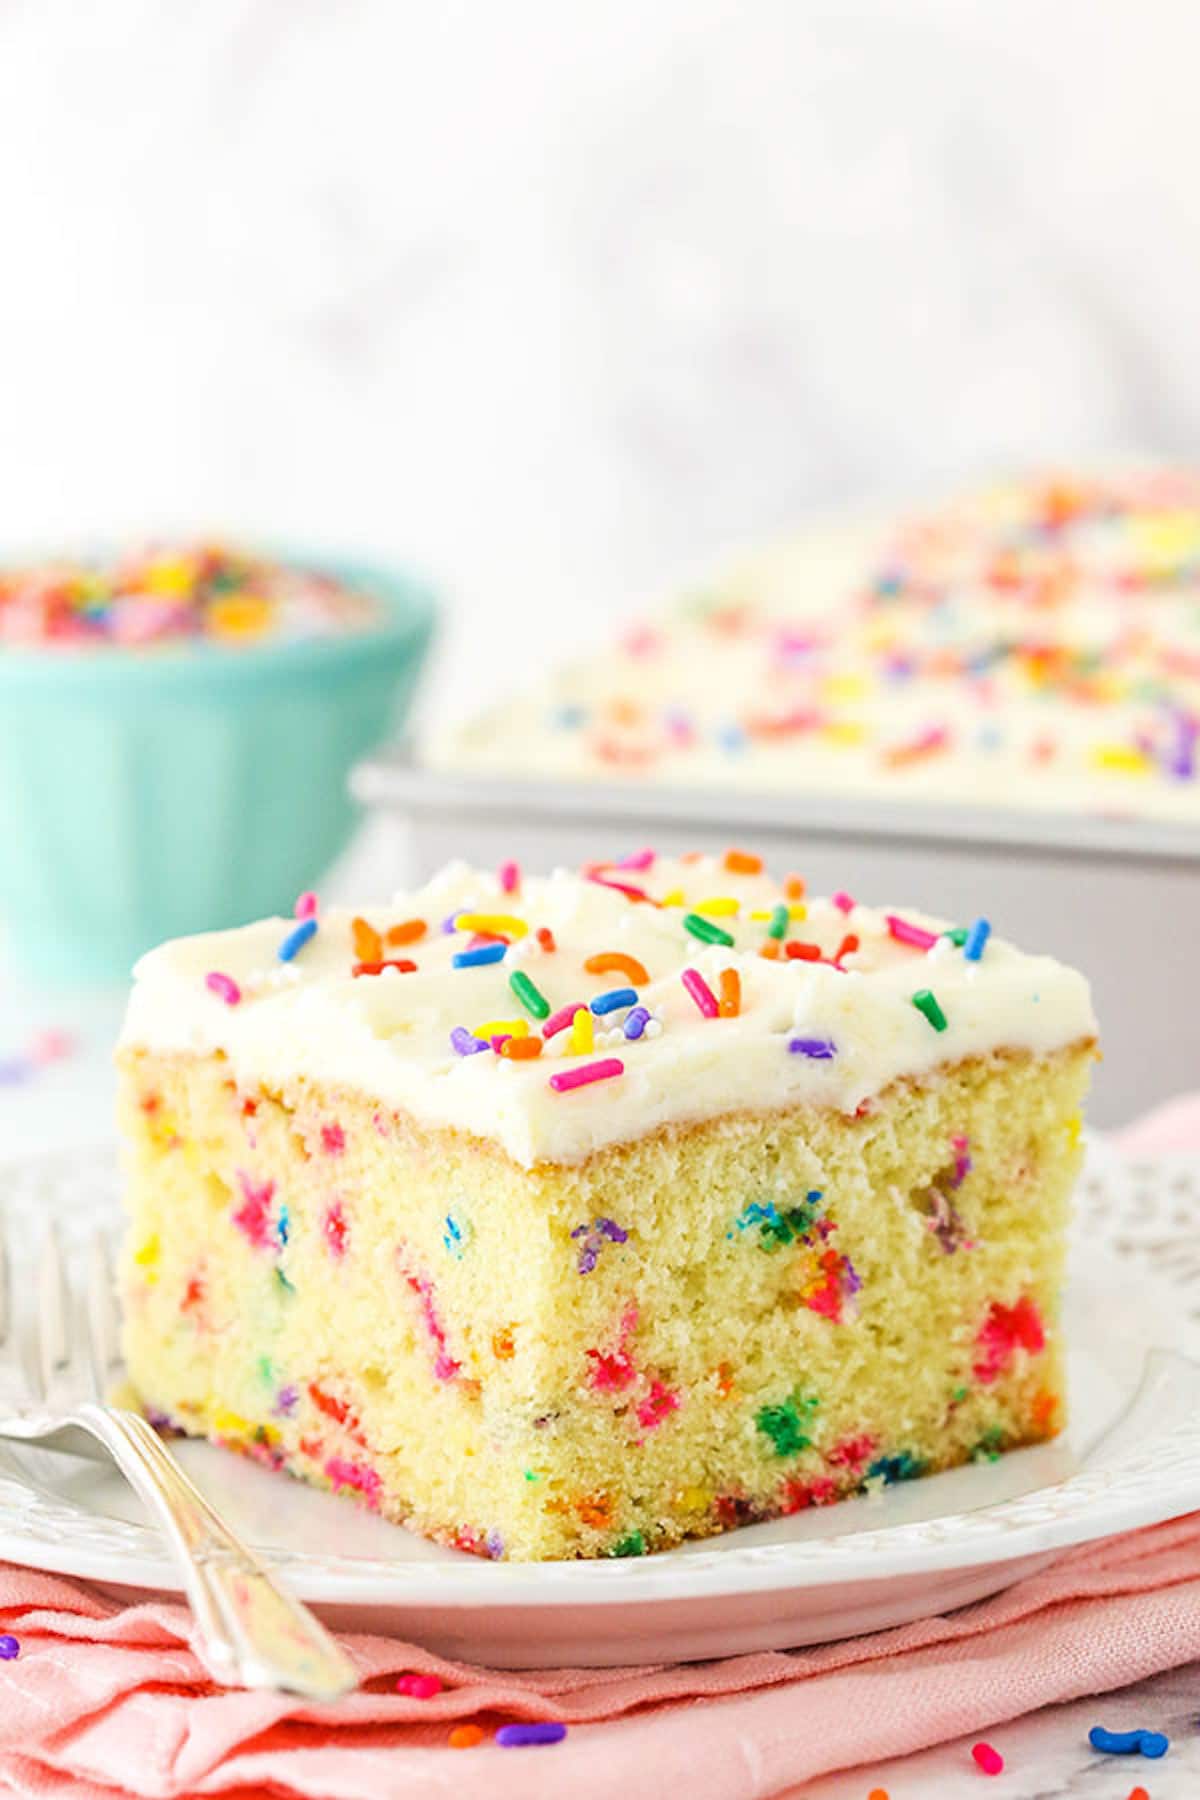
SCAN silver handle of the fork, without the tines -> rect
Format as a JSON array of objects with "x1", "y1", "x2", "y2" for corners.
[{"x1": 74, "y1": 1402, "x2": 358, "y2": 1699}]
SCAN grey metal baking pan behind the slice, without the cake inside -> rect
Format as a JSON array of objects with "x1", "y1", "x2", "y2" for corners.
[{"x1": 353, "y1": 747, "x2": 1200, "y2": 1125}]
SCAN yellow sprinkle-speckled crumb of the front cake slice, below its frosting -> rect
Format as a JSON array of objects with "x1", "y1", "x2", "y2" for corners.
[{"x1": 121, "y1": 1040, "x2": 1094, "y2": 1559}]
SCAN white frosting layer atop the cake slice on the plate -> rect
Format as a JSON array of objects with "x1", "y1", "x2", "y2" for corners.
[{"x1": 122, "y1": 857, "x2": 1096, "y2": 1165}]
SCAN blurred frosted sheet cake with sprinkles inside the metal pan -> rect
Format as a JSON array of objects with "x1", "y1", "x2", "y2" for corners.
[{"x1": 437, "y1": 468, "x2": 1200, "y2": 821}]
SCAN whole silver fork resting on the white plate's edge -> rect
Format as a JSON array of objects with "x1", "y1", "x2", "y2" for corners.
[{"x1": 0, "y1": 1224, "x2": 358, "y2": 1699}]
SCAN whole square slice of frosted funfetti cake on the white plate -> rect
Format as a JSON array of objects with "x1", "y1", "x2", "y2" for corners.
[{"x1": 119, "y1": 851, "x2": 1096, "y2": 1559}]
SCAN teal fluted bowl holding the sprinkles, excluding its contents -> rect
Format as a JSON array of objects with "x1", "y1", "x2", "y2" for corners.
[{"x1": 0, "y1": 551, "x2": 435, "y2": 983}]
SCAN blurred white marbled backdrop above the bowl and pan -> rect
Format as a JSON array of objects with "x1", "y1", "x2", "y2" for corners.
[{"x1": 0, "y1": 0, "x2": 1200, "y2": 711}]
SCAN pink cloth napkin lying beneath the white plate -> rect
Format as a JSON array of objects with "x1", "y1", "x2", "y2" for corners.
[{"x1": 0, "y1": 1096, "x2": 1200, "y2": 1800}]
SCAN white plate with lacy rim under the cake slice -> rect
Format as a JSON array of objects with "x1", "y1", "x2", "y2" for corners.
[{"x1": 0, "y1": 1147, "x2": 1200, "y2": 1669}]
